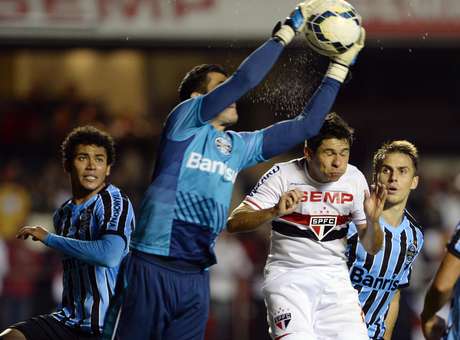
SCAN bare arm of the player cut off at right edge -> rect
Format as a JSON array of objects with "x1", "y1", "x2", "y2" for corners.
[{"x1": 421, "y1": 252, "x2": 460, "y2": 339}]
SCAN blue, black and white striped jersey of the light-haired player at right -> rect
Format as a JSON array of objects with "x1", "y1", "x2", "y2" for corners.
[{"x1": 347, "y1": 211, "x2": 423, "y2": 339}]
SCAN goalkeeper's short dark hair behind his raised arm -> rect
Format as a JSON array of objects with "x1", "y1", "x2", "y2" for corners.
[{"x1": 178, "y1": 64, "x2": 228, "y2": 101}]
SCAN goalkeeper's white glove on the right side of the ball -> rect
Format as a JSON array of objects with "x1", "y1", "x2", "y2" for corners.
[{"x1": 326, "y1": 27, "x2": 366, "y2": 83}]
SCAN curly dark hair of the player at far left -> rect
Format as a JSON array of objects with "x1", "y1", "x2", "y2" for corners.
[{"x1": 61, "y1": 125, "x2": 115, "y2": 170}]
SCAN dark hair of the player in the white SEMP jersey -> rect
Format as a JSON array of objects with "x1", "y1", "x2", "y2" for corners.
[{"x1": 305, "y1": 112, "x2": 354, "y2": 152}]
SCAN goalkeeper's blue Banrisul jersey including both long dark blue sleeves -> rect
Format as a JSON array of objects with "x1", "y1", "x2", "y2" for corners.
[{"x1": 127, "y1": 39, "x2": 340, "y2": 267}]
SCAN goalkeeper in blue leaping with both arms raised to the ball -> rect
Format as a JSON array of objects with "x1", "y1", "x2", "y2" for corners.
[{"x1": 104, "y1": 0, "x2": 364, "y2": 339}]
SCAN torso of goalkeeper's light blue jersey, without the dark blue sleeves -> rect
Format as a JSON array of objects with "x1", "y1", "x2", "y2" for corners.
[{"x1": 131, "y1": 96, "x2": 264, "y2": 267}]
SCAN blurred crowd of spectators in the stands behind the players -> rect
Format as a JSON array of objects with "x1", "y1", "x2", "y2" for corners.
[{"x1": 0, "y1": 87, "x2": 460, "y2": 340}]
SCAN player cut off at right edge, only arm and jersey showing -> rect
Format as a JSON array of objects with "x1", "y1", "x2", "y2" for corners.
[{"x1": 421, "y1": 223, "x2": 460, "y2": 340}]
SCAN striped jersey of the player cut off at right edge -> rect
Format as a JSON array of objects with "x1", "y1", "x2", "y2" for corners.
[{"x1": 445, "y1": 223, "x2": 460, "y2": 340}]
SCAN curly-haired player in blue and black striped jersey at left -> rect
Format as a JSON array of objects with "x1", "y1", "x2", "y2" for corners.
[{"x1": 0, "y1": 126, "x2": 134, "y2": 340}]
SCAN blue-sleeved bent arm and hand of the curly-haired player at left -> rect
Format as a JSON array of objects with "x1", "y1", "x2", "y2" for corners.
[{"x1": 16, "y1": 226, "x2": 126, "y2": 267}]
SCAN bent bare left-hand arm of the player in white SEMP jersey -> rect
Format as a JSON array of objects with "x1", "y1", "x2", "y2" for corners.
[{"x1": 227, "y1": 189, "x2": 302, "y2": 233}]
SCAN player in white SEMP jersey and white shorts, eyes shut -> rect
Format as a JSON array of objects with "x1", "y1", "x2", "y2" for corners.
[{"x1": 227, "y1": 113, "x2": 386, "y2": 340}]
